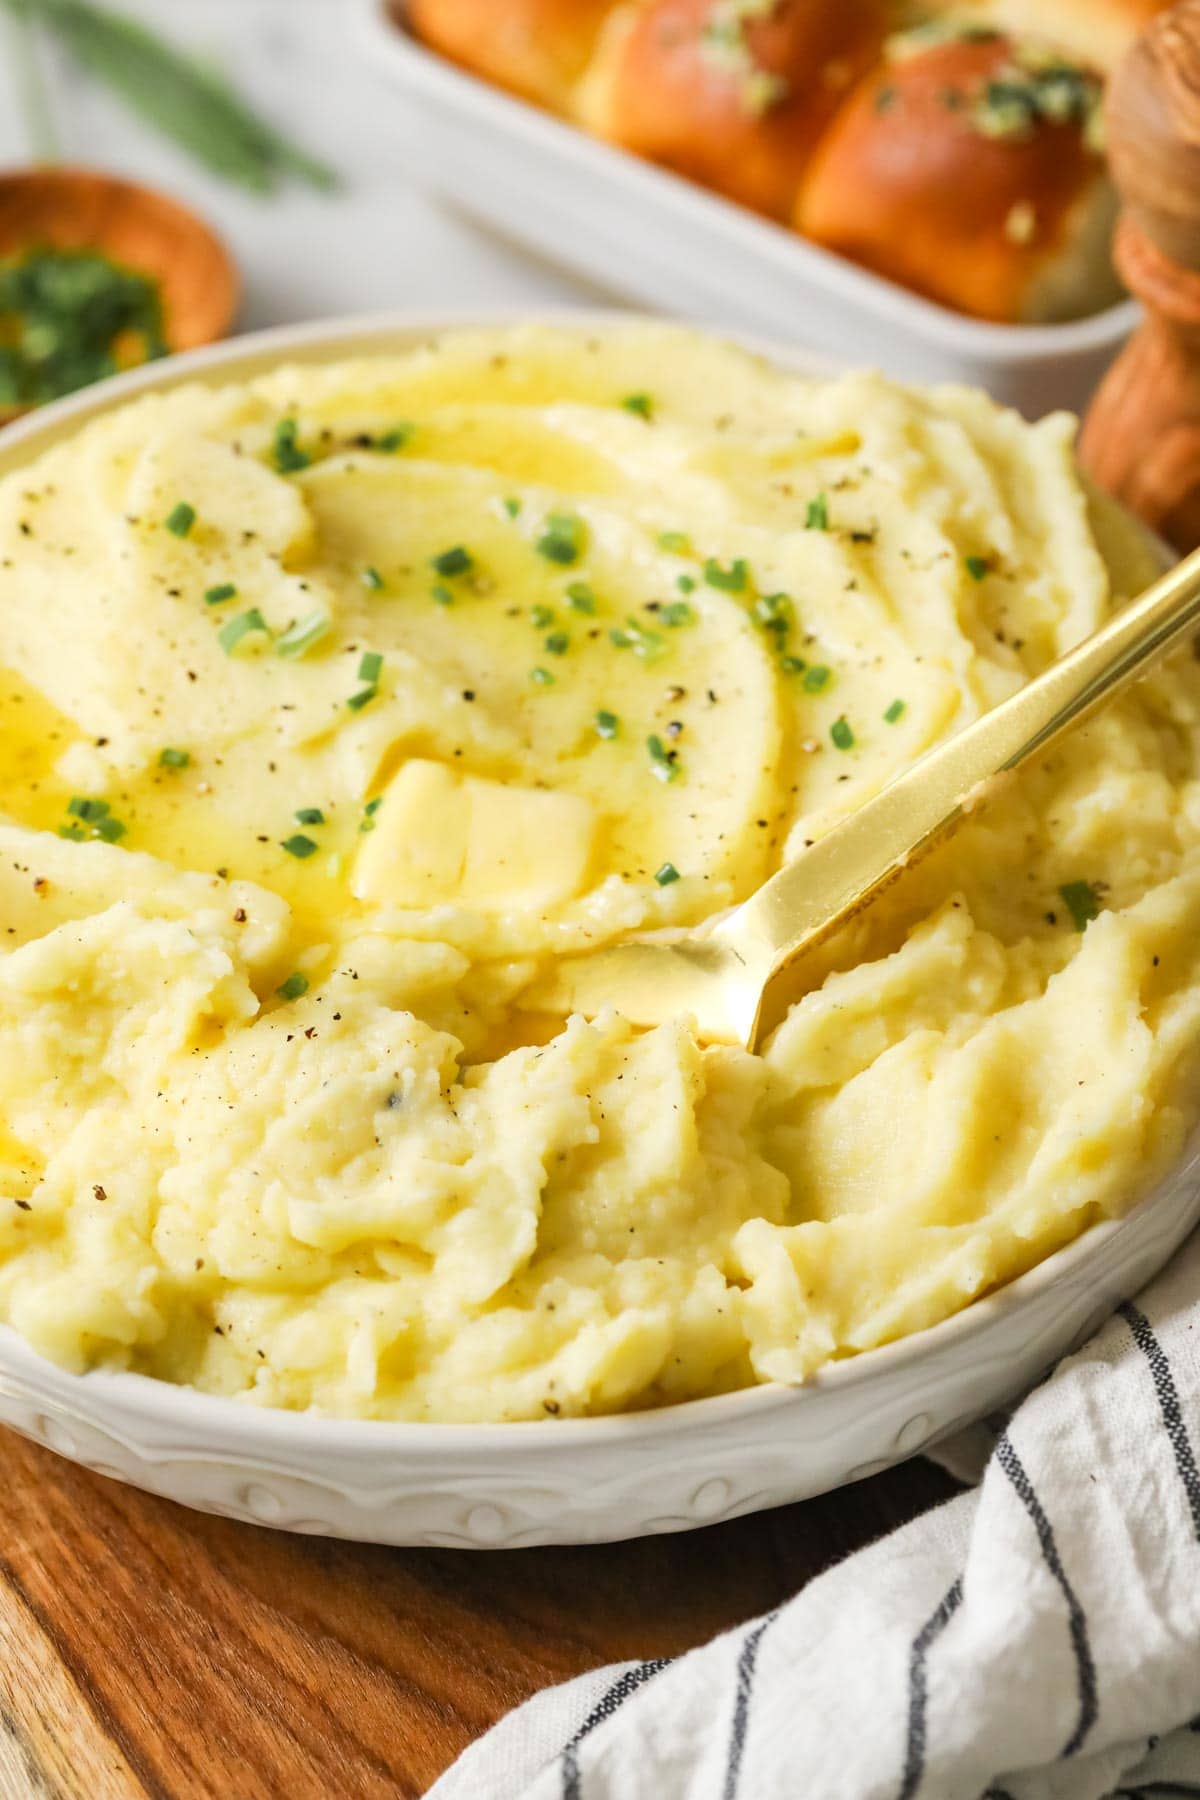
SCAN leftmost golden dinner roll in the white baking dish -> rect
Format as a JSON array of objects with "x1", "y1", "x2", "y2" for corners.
[{"x1": 403, "y1": 0, "x2": 615, "y2": 112}]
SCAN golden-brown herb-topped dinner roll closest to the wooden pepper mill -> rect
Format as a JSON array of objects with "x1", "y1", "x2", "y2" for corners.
[{"x1": 795, "y1": 31, "x2": 1119, "y2": 322}]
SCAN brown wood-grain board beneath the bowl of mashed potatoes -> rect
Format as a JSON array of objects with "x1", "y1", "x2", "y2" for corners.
[{"x1": 0, "y1": 1431, "x2": 955, "y2": 1800}]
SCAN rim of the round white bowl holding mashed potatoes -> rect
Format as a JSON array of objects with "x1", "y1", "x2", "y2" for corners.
[{"x1": 0, "y1": 304, "x2": 1180, "y2": 1456}]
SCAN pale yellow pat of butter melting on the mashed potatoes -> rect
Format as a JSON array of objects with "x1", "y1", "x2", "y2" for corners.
[{"x1": 351, "y1": 758, "x2": 596, "y2": 913}]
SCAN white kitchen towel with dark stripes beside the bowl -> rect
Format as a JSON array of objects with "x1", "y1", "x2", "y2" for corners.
[{"x1": 430, "y1": 1237, "x2": 1200, "y2": 1800}]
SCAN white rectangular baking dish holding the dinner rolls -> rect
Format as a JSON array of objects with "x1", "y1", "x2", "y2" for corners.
[{"x1": 356, "y1": 0, "x2": 1137, "y2": 418}]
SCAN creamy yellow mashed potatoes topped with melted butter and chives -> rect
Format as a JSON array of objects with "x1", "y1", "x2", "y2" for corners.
[{"x1": 0, "y1": 326, "x2": 1200, "y2": 1420}]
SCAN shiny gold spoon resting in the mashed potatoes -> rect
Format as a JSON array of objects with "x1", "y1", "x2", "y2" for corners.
[{"x1": 522, "y1": 551, "x2": 1200, "y2": 1049}]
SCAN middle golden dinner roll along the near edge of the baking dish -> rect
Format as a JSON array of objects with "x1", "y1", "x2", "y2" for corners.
[{"x1": 579, "y1": 0, "x2": 889, "y2": 220}]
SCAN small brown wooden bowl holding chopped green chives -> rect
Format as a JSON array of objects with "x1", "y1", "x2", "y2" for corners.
[{"x1": 0, "y1": 167, "x2": 241, "y2": 419}]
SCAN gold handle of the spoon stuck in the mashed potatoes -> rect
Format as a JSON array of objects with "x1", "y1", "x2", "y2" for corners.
[{"x1": 714, "y1": 536, "x2": 1200, "y2": 1042}]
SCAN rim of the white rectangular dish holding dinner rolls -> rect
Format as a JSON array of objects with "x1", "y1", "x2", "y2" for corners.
[{"x1": 354, "y1": 0, "x2": 1141, "y2": 364}]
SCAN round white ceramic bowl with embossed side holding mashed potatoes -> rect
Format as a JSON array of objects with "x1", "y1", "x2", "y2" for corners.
[{"x1": 0, "y1": 313, "x2": 1200, "y2": 1548}]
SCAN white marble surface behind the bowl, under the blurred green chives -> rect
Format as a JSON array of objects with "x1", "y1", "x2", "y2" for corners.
[{"x1": 0, "y1": 0, "x2": 610, "y2": 329}]
